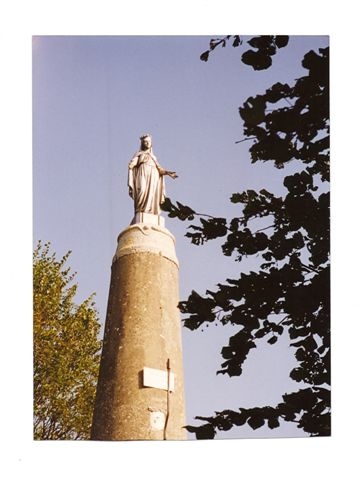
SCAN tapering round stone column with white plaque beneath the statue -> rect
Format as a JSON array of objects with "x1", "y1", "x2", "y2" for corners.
[{"x1": 91, "y1": 214, "x2": 186, "y2": 440}]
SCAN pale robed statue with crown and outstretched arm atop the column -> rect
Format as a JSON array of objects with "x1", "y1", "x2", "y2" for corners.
[{"x1": 128, "y1": 134, "x2": 178, "y2": 215}]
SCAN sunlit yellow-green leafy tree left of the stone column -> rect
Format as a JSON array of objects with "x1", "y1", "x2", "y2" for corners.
[{"x1": 33, "y1": 242, "x2": 101, "y2": 440}]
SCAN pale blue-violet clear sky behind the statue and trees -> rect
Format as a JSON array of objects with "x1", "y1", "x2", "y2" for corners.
[{"x1": 33, "y1": 36, "x2": 329, "y2": 438}]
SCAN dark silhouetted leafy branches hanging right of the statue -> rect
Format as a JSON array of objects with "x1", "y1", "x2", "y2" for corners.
[{"x1": 164, "y1": 36, "x2": 330, "y2": 438}]
